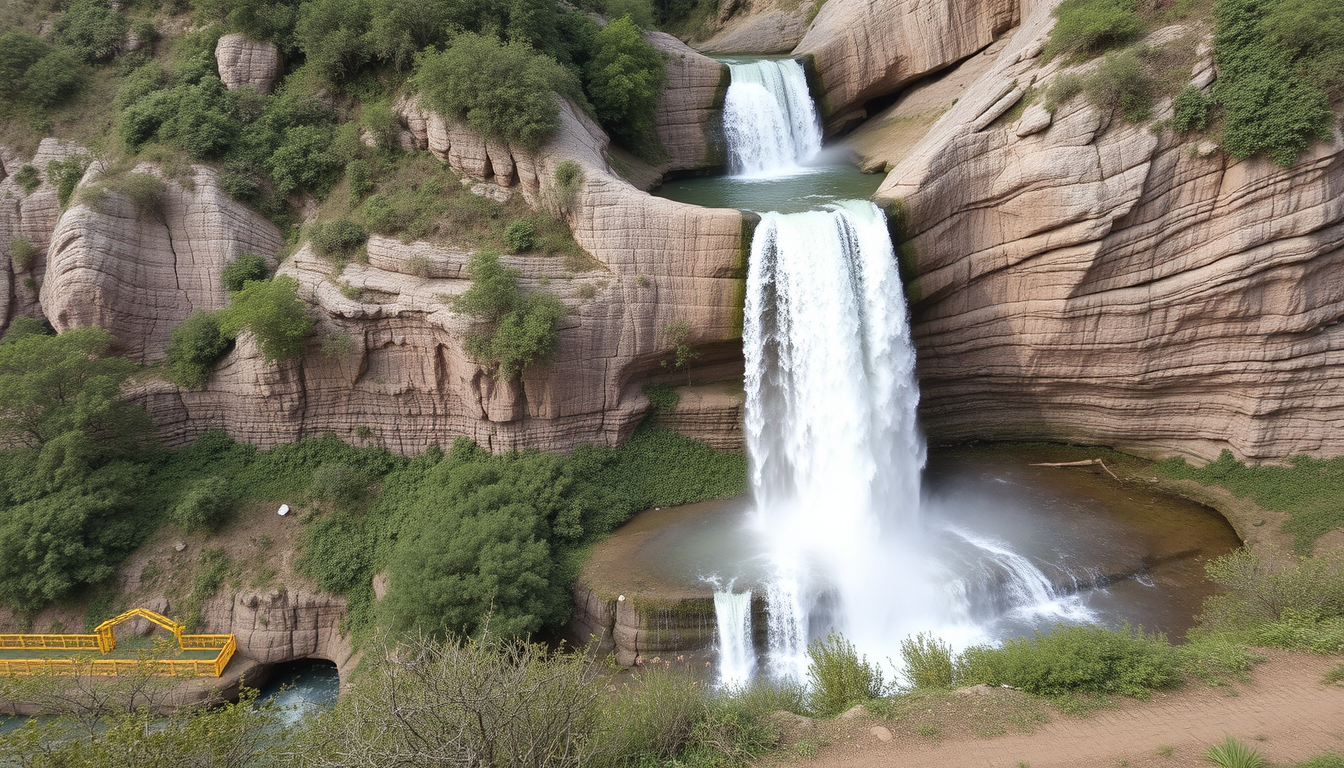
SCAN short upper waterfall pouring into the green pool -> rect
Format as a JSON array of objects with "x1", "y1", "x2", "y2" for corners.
[{"x1": 723, "y1": 59, "x2": 821, "y2": 176}]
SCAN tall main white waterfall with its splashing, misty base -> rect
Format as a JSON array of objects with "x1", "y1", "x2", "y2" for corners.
[{"x1": 743, "y1": 202, "x2": 1085, "y2": 679}]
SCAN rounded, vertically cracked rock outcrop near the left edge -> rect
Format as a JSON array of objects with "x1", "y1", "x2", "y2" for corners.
[{"x1": 42, "y1": 165, "x2": 281, "y2": 362}]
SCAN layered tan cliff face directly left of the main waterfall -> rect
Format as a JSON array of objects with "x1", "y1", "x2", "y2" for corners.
[{"x1": 140, "y1": 98, "x2": 745, "y2": 453}]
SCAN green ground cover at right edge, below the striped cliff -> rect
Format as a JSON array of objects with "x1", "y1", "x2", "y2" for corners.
[{"x1": 1154, "y1": 451, "x2": 1344, "y2": 554}]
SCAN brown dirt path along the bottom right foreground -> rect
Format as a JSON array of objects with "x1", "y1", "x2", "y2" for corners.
[{"x1": 784, "y1": 651, "x2": 1344, "y2": 768}]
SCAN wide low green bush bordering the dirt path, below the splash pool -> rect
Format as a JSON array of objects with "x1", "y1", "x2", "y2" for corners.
[{"x1": 962, "y1": 624, "x2": 1180, "y2": 697}]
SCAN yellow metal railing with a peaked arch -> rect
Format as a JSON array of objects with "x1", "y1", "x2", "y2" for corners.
[{"x1": 0, "y1": 608, "x2": 238, "y2": 678}]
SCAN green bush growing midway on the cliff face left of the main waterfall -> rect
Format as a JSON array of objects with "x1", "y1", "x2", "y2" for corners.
[{"x1": 453, "y1": 252, "x2": 564, "y2": 381}]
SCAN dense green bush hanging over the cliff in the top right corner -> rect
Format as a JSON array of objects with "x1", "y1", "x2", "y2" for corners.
[{"x1": 1214, "y1": 0, "x2": 1337, "y2": 165}]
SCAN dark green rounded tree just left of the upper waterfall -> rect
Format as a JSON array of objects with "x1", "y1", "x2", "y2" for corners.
[{"x1": 585, "y1": 16, "x2": 667, "y2": 145}]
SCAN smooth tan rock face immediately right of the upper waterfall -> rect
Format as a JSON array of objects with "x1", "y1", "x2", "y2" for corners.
[{"x1": 793, "y1": 0, "x2": 1020, "y2": 124}]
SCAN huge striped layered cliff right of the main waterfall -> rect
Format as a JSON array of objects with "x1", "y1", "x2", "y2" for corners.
[{"x1": 879, "y1": 4, "x2": 1344, "y2": 460}]
